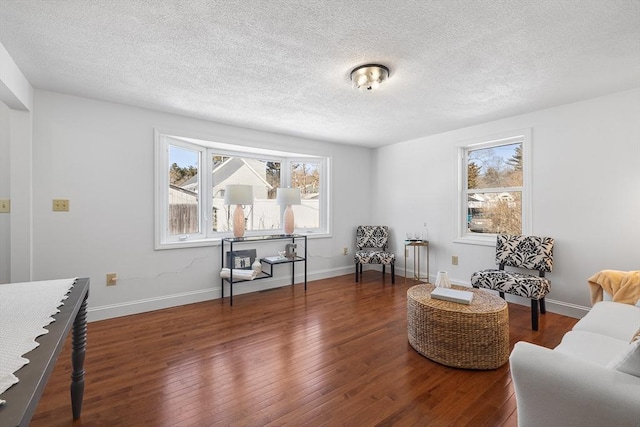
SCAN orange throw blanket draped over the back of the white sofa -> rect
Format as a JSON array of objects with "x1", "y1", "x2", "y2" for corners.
[{"x1": 588, "y1": 270, "x2": 640, "y2": 305}]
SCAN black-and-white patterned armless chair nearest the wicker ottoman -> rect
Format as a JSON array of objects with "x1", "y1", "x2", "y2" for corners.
[{"x1": 471, "y1": 234, "x2": 554, "y2": 331}]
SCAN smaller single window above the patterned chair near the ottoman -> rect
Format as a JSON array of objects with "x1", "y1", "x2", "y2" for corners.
[{"x1": 458, "y1": 129, "x2": 531, "y2": 243}]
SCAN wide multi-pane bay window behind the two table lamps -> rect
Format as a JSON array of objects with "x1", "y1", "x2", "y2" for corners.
[{"x1": 155, "y1": 131, "x2": 329, "y2": 249}]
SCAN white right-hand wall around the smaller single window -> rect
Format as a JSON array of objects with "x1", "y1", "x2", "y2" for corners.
[{"x1": 372, "y1": 89, "x2": 640, "y2": 316}]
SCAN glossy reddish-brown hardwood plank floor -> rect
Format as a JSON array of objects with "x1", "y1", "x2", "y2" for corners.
[{"x1": 32, "y1": 271, "x2": 576, "y2": 426}]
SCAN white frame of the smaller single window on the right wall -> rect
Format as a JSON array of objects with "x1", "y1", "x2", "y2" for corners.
[{"x1": 454, "y1": 128, "x2": 532, "y2": 246}]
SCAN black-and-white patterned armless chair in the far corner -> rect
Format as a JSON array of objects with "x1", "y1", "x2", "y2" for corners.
[{"x1": 353, "y1": 225, "x2": 396, "y2": 283}]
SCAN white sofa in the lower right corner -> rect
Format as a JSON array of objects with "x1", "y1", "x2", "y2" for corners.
[{"x1": 509, "y1": 301, "x2": 640, "y2": 427}]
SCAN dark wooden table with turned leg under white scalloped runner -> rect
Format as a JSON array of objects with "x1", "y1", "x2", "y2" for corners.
[{"x1": 0, "y1": 278, "x2": 89, "y2": 427}]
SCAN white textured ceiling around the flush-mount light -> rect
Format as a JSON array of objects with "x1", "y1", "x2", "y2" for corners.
[{"x1": 0, "y1": 0, "x2": 640, "y2": 147}]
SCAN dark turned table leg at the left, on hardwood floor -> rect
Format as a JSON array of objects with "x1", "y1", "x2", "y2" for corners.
[{"x1": 71, "y1": 295, "x2": 88, "y2": 420}]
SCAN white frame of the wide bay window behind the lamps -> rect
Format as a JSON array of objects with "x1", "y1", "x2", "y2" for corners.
[{"x1": 154, "y1": 129, "x2": 330, "y2": 250}]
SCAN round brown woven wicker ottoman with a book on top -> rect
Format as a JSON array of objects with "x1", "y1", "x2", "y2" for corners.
[{"x1": 407, "y1": 284, "x2": 509, "y2": 369}]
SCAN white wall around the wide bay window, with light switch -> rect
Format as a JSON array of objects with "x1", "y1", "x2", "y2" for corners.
[{"x1": 27, "y1": 90, "x2": 372, "y2": 320}]
